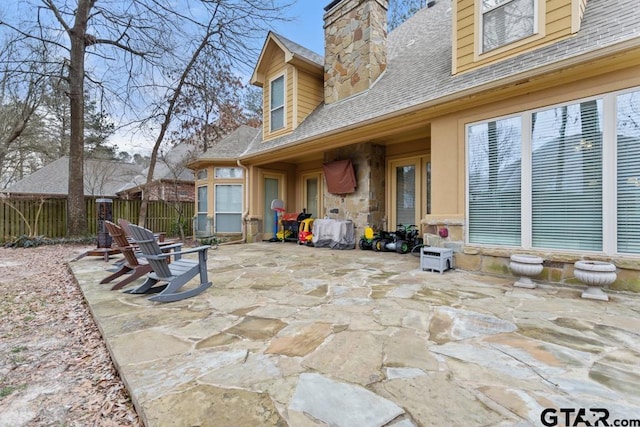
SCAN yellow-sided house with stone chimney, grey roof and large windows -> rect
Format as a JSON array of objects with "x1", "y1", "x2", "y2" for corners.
[{"x1": 191, "y1": 0, "x2": 640, "y2": 291}]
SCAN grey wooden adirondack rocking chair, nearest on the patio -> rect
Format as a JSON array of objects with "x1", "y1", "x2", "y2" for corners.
[{"x1": 125, "y1": 224, "x2": 211, "y2": 302}]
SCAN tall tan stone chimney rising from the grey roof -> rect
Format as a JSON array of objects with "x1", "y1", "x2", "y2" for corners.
[{"x1": 324, "y1": 0, "x2": 389, "y2": 104}]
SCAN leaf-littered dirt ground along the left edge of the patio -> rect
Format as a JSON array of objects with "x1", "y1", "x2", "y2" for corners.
[{"x1": 0, "y1": 245, "x2": 142, "y2": 427}]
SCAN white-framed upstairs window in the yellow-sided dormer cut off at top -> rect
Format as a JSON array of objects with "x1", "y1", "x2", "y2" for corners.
[{"x1": 481, "y1": 0, "x2": 537, "y2": 52}]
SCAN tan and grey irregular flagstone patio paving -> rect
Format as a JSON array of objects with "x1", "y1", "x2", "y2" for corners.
[{"x1": 70, "y1": 243, "x2": 640, "y2": 427}]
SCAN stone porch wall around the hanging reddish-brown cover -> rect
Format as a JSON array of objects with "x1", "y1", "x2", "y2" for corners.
[{"x1": 323, "y1": 143, "x2": 385, "y2": 234}]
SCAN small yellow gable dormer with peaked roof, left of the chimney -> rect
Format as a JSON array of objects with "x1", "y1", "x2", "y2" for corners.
[{"x1": 251, "y1": 32, "x2": 324, "y2": 140}]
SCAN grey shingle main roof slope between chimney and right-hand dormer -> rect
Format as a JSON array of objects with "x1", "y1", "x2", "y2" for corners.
[{"x1": 243, "y1": 0, "x2": 640, "y2": 157}]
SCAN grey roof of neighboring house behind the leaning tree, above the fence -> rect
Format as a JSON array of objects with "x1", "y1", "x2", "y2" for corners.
[{"x1": 117, "y1": 144, "x2": 198, "y2": 193}]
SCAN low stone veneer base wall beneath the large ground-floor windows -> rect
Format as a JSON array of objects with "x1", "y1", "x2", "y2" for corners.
[{"x1": 423, "y1": 219, "x2": 640, "y2": 292}]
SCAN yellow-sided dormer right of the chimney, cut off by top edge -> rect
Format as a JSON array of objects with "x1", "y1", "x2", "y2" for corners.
[{"x1": 452, "y1": 0, "x2": 587, "y2": 74}]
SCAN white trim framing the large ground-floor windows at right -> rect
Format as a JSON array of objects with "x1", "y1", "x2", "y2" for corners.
[{"x1": 464, "y1": 87, "x2": 640, "y2": 256}]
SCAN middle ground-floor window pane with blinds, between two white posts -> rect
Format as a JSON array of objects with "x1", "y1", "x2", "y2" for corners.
[{"x1": 531, "y1": 100, "x2": 603, "y2": 251}]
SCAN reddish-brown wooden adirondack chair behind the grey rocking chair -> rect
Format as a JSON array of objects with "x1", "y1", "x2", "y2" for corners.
[{"x1": 100, "y1": 221, "x2": 182, "y2": 291}]
